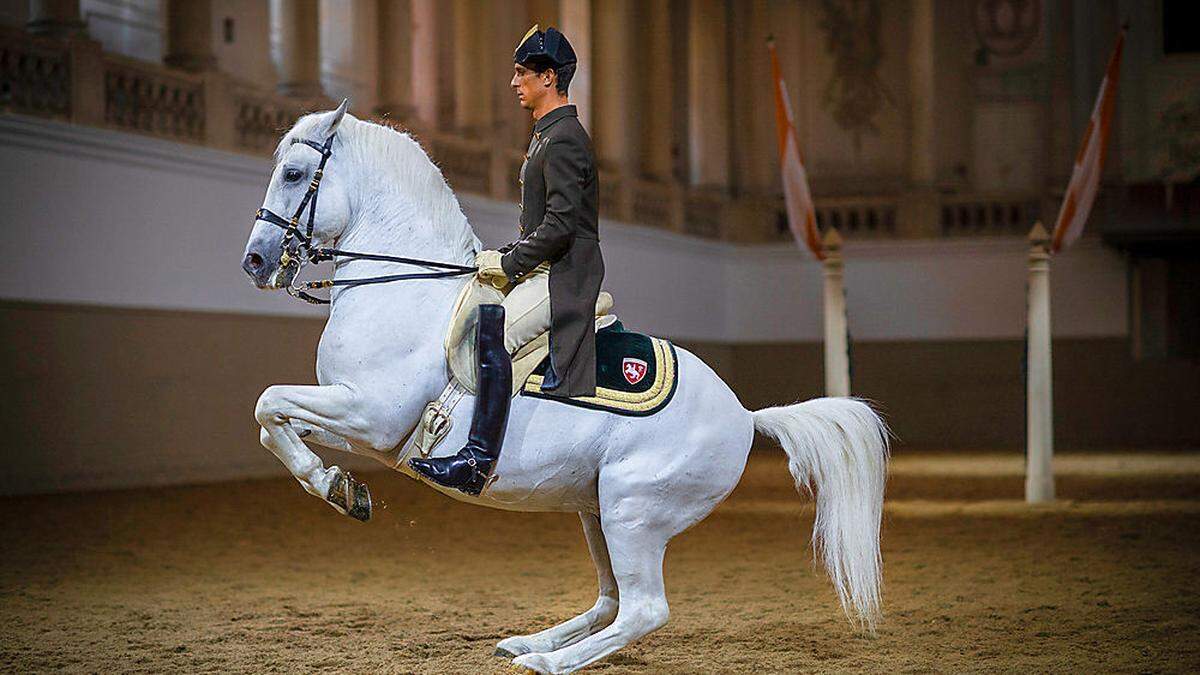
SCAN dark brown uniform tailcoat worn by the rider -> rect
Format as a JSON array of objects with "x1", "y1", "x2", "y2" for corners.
[{"x1": 500, "y1": 106, "x2": 604, "y2": 396}]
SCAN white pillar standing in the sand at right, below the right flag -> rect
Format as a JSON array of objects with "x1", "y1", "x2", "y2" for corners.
[{"x1": 1025, "y1": 222, "x2": 1054, "y2": 503}]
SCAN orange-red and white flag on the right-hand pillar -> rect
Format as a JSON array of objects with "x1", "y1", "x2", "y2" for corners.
[{"x1": 1050, "y1": 29, "x2": 1126, "y2": 253}]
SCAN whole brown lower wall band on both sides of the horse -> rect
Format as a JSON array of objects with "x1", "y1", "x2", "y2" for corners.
[{"x1": 0, "y1": 301, "x2": 1200, "y2": 494}]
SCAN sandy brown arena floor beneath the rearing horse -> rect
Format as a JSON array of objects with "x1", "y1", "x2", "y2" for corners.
[{"x1": 0, "y1": 453, "x2": 1200, "y2": 674}]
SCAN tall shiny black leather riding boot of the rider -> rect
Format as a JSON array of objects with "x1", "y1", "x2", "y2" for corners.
[{"x1": 408, "y1": 305, "x2": 512, "y2": 495}]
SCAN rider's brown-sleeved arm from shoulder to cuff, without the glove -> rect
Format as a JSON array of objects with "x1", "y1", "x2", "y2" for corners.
[{"x1": 500, "y1": 137, "x2": 589, "y2": 281}]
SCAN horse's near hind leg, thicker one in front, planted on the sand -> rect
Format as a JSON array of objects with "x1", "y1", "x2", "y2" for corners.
[{"x1": 512, "y1": 497, "x2": 678, "y2": 673}]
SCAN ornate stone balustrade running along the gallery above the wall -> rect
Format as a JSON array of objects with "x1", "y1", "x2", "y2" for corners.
[{"x1": 0, "y1": 28, "x2": 1044, "y2": 243}]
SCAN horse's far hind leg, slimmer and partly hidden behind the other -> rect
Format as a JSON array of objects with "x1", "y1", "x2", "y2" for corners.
[{"x1": 496, "y1": 513, "x2": 618, "y2": 658}]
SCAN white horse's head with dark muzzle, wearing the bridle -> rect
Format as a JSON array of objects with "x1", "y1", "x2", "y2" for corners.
[{"x1": 241, "y1": 101, "x2": 356, "y2": 288}]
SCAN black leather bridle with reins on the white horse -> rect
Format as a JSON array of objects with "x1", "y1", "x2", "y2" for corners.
[{"x1": 254, "y1": 133, "x2": 475, "y2": 305}]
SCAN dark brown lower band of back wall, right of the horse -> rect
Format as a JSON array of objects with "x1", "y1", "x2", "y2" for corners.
[{"x1": 700, "y1": 338, "x2": 1200, "y2": 450}]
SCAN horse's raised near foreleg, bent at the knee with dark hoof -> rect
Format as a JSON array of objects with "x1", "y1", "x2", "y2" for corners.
[{"x1": 254, "y1": 384, "x2": 395, "y2": 520}]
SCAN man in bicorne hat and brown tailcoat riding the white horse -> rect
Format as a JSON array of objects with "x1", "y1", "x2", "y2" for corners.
[{"x1": 409, "y1": 25, "x2": 604, "y2": 495}]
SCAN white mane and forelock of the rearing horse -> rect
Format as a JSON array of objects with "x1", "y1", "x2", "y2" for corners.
[{"x1": 275, "y1": 113, "x2": 481, "y2": 264}]
